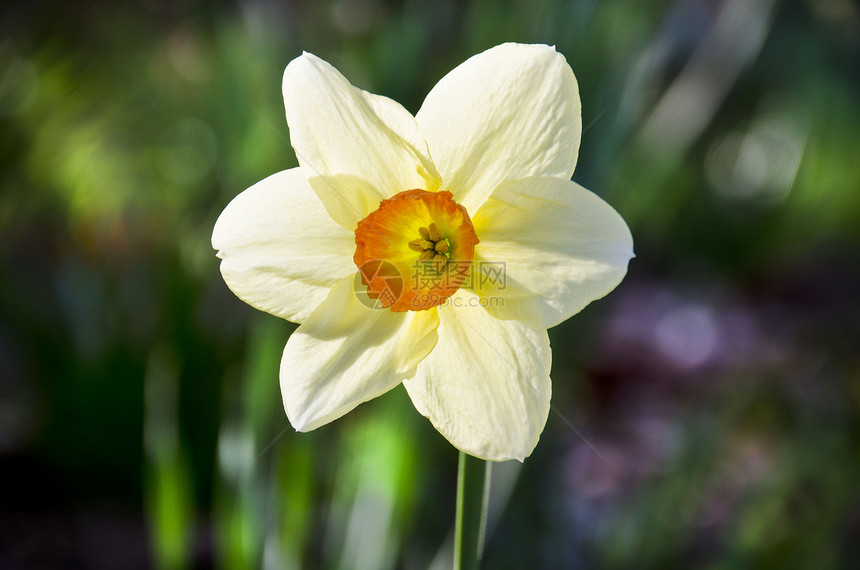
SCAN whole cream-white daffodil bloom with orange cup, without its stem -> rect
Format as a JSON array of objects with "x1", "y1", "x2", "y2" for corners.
[{"x1": 212, "y1": 44, "x2": 633, "y2": 461}]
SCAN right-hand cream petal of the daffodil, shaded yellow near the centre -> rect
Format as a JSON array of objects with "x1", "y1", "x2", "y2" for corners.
[{"x1": 473, "y1": 178, "x2": 633, "y2": 328}]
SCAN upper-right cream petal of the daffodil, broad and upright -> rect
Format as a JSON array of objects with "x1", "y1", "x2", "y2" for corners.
[{"x1": 416, "y1": 44, "x2": 582, "y2": 212}]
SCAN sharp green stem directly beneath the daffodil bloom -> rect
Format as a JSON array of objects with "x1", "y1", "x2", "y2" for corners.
[{"x1": 454, "y1": 451, "x2": 490, "y2": 570}]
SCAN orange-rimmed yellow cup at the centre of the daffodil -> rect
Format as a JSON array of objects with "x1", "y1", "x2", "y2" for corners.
[{"x1": 353, "y1": 190, "x2": 478, "y2": 312}]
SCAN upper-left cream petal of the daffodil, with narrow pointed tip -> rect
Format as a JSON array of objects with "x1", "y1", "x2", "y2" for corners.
[{"x1": 283, "y1": 53, "x2": 439, "y2": 230}]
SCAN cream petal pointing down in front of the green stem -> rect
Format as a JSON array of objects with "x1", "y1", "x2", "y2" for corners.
[{"x1": 403, "y1": 289, "x2": 552, "y2": 461}]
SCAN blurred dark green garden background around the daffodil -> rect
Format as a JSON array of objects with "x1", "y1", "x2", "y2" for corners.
[{"x1": 0, "y1": 0, "x2": 860, "y2": 570}]
